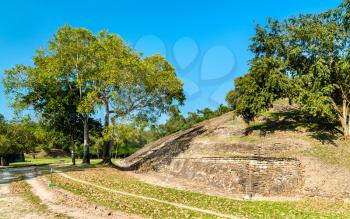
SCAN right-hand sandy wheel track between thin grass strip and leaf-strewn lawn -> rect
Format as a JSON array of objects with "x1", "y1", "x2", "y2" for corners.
[{"x1": 25, "y1": 172, "x2": 140, "y2": 219}]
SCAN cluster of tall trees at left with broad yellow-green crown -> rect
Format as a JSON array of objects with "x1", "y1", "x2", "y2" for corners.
[{"x1": 3, "y1": 25, "x2": 185, "y2": 164}]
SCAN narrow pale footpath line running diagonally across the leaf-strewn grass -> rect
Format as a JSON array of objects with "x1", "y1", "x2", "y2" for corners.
[{"x1": 58, "y1": 172, "x2": 236, "y2": 218}]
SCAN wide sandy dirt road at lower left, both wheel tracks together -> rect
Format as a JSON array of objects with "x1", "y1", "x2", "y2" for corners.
[{"x1": 0, "y1": 167, "x2": 141, "y2": 219}]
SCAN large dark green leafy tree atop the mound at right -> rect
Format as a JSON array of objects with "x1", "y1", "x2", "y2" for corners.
[{"x1": 228, "y1": 1, "x2": 350, "y2": 138}]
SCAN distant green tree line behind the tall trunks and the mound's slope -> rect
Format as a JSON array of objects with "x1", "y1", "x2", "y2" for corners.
[{"x1": 0, "y1": 102, "x2": 231, "y2": 165}]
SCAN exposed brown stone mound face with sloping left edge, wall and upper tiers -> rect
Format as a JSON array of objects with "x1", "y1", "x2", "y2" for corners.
[{"x1": 120, "y1": 113, "x2": 304, "y2": 196}]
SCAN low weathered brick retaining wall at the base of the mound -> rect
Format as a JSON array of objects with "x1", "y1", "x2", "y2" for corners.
[{"x1": 168, "y1": 157, "x2": 303, "y2": 195}]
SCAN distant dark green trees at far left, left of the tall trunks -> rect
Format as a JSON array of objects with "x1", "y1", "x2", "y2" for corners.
[{"x1": 0, "y1": 114, "x2": 102, "y2": 166}]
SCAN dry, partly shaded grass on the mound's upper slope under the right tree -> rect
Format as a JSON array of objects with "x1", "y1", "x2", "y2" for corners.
[{"x1": 224, "y1": 108, "x2": 350, "y2": 169}]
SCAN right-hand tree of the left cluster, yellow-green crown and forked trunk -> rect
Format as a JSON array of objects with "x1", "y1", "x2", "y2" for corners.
[{"x1": 94, "y1": 31, "x2": 184, "y2": 163}]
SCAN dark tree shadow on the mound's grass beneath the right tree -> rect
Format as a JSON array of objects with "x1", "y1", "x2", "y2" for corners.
[{"x1": 245, "y1": 110, "x2": 342, "y2": 146}]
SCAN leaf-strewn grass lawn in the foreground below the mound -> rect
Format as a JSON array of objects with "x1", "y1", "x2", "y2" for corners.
[{"x1": 50, "y1": 168, "x2": 350, "y2": 218}]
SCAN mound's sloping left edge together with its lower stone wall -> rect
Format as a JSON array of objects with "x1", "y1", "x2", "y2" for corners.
[{"x1": 122, "y1": 113, "x2": 303, "y2": 196}]
